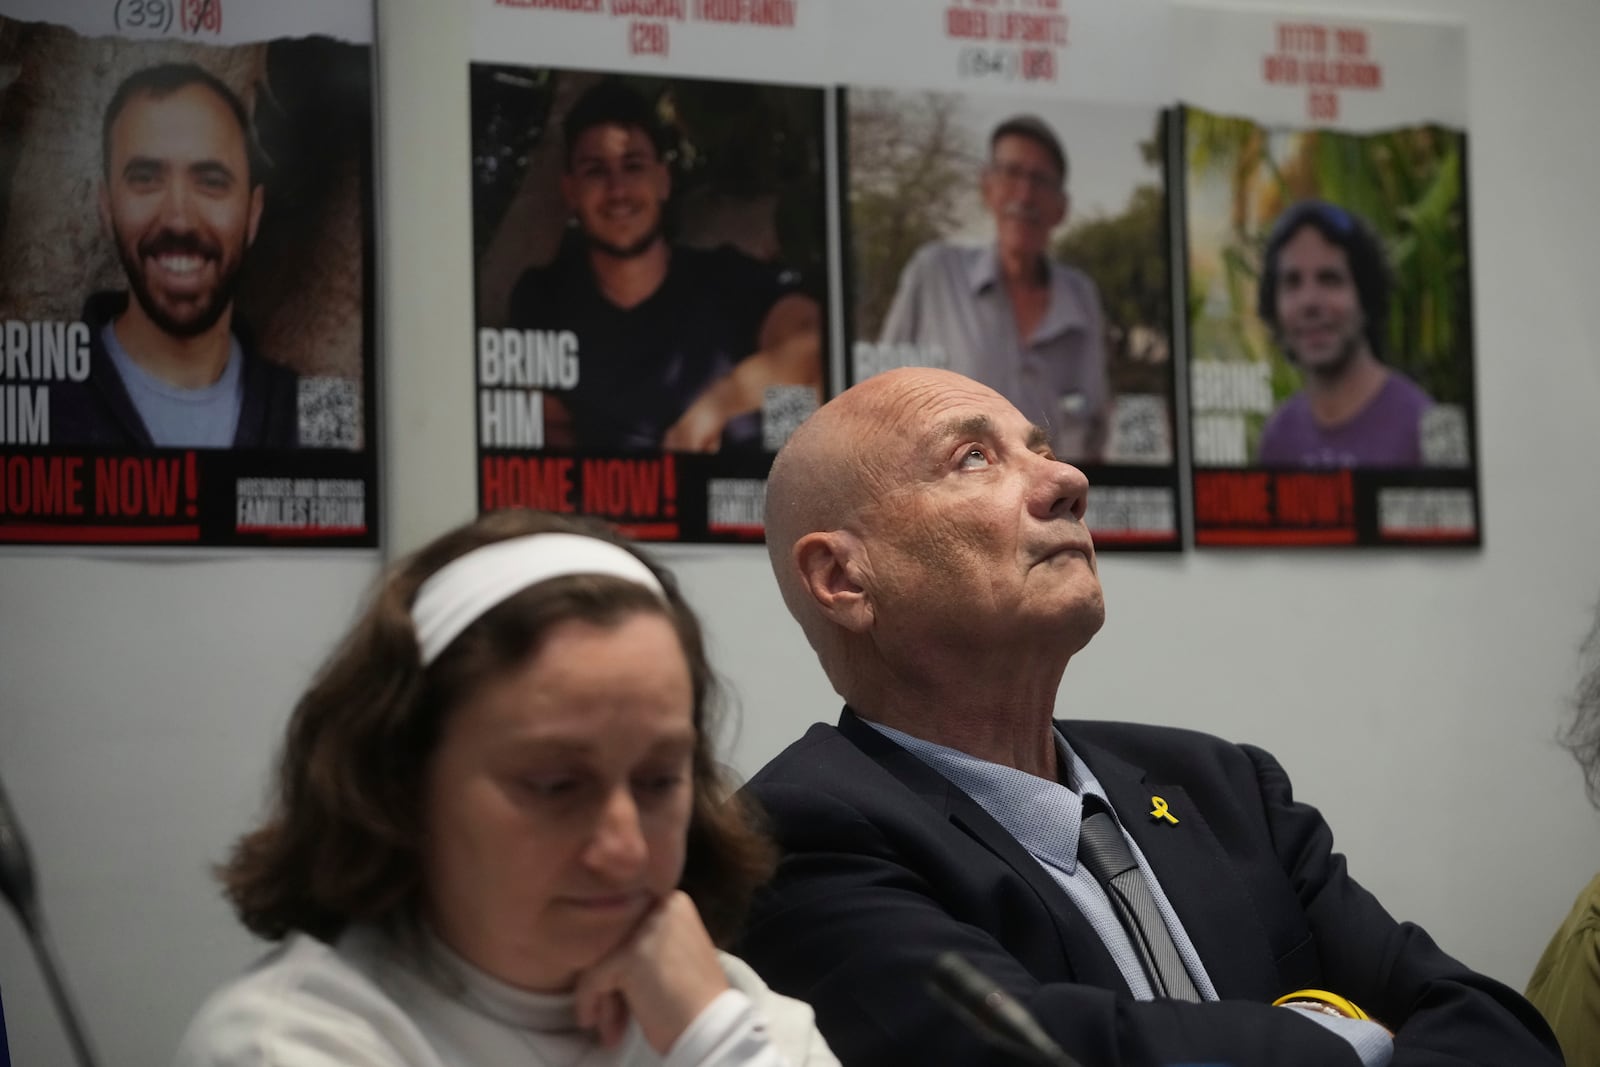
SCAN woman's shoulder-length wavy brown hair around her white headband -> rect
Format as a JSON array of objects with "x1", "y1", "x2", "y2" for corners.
[{"x1": 218, "y1": 510, "x2": 776, "y2": 944}]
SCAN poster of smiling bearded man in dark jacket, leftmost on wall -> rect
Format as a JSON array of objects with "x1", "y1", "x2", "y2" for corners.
[{"x1": 0, "y1": 0, "x2": 378, "y2": 547}]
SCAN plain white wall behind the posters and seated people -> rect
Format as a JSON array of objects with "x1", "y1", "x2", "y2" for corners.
[{"x1": 0, "y1": 0, "x2": 1600, "y2": 1067}]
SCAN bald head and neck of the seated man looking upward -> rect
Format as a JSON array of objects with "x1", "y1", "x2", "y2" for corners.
[{"x1": 766, "y1": 368, "x2": 1104, "y2": 736}]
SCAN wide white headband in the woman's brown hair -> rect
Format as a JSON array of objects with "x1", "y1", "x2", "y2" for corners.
[{"x1": 411, "y1": 533, "x2": 666, "y2": 667}]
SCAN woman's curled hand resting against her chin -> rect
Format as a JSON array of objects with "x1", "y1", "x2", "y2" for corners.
[{"x1": 576, "y1": 889, "x2": 728, "y2": 1056}]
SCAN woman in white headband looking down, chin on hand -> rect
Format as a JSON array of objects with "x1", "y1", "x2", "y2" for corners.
[{"x1": 178, "y1": 512, "x2": 837, "y2": 1067}]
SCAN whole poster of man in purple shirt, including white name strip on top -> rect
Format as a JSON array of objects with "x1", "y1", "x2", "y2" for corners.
[{"x1": 1179, "y1": 8, "x2": 1482, "y2": 556}]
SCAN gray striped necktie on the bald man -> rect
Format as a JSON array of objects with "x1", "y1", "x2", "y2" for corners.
[{"x1": 1078, "y1": 793, "x2": 1200, "y2": 1001}]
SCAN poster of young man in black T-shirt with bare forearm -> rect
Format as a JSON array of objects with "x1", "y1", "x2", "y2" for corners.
[{"x1": 472, "y1": 5, "x2": 829, "y2": 541}]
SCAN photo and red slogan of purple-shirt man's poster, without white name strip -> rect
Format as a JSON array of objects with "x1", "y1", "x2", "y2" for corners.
[{"x1": 1181, "y1": 107, "x2": 1482, "y2": 547}]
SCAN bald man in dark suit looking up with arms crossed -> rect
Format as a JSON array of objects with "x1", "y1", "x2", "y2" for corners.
[{"x1": 739, "y1": 370, "x2": 1560, "y2": 1067}]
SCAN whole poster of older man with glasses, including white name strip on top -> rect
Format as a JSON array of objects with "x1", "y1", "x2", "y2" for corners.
[{"x1": 837, "y1": 3, "x2": 1182, "y2": 550}]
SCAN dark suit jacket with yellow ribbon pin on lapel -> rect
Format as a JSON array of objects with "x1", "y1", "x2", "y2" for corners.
[{"x1": 738, "y1": 709, "x2": 1562, "y2": 1067}]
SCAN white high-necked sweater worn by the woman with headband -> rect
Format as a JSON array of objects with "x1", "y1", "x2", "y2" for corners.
[{"x1": 174, "y1": 926, "x2": 838, "y2": 1067}]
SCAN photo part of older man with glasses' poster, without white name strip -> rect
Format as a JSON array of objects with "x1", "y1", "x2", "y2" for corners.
[{"x1": 842, "y1": 88, "x2": 1178, "y2": 549}]
